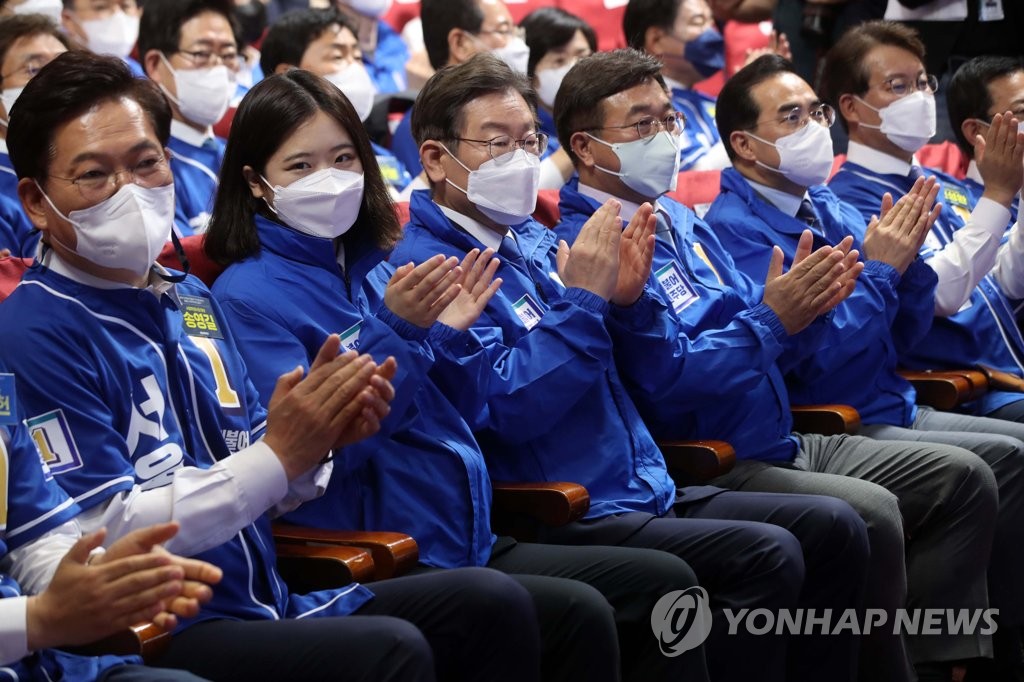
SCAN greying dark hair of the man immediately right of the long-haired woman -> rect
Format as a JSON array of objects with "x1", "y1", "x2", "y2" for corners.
[{"x1": 410, "y1": 52, "x2": 537, "y2": 144}]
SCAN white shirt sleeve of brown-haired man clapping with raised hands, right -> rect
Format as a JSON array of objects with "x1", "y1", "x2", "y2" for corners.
[{"x1": 926, "y1": 198, "x2": 1010, "y2": 317}]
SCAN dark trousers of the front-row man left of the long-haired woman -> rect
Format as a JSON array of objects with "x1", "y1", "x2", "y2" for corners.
[{"x1": 157, "y1": 568, "x2": 541, "y2": 682}]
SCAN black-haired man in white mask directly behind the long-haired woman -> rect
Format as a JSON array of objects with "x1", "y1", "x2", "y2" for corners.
[{"x1": 260, "y1": 9, "x2": 413, "y2": 196}]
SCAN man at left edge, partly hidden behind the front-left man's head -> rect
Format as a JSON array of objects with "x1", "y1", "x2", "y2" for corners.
[{"x1": 0, "y1": 14, "x2": 70, "y2": 258}]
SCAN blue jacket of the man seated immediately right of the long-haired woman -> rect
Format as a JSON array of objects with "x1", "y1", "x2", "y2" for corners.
[{"x1": 391, "y1": 190, "x2": 675, "y2": 518}]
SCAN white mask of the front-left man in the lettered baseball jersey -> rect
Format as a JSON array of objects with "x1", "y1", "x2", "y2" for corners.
[{"x1": 39, "y1": 183, "x2": 174, "y2": 276}]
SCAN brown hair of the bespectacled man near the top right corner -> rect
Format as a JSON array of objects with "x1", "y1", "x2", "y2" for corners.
[{"x1": 818, "y1": 19, "x2": 925, "y2": 130}]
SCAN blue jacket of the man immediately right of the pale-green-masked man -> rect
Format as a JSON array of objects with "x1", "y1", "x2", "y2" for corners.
[{"x1": 705, "y1": 169, "x2": 936, "y2": 426}]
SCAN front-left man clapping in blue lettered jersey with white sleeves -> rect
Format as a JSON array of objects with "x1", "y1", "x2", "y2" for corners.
[{"x1": 0, "y1": 51, "x2": 552, "y2": 681}]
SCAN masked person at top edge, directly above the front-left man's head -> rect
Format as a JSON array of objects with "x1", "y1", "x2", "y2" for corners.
[{"x1": 60, "y1": 0, "x2": 145, "y2": 76}]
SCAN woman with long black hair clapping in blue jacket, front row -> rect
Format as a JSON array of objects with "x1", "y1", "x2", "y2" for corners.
[{"x1": 206, "y1": 70, "x2": 707, "y2": 680}]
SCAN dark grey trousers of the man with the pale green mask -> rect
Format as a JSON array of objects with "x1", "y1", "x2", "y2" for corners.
[{"x1": 715, "y1": 434, "x2": 996, "y2": 681}]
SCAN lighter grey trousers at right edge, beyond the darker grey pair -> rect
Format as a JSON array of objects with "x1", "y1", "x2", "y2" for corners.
[{"x1": 861, "y1": 408, "x2": 1024, "y2": 626}]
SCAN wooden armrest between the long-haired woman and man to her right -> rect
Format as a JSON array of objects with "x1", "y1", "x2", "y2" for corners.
[{"x1": 490, "y1": 481, "x2": 590, "y2": 542}]
